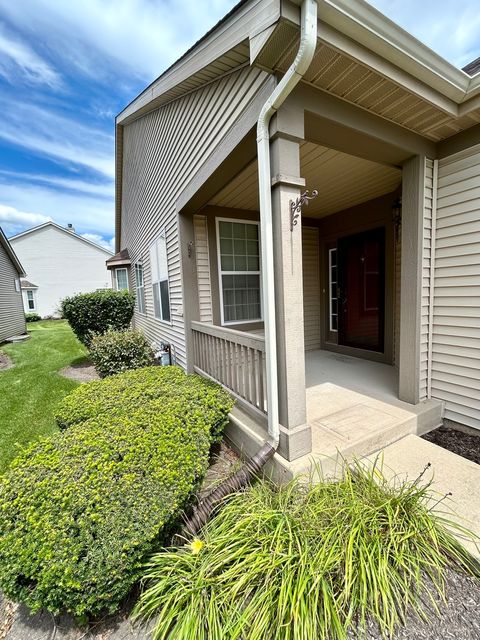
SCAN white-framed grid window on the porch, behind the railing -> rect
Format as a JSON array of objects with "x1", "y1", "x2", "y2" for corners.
[{"x1": 217, "y1": 219, "x2": 262, "y2": 324}]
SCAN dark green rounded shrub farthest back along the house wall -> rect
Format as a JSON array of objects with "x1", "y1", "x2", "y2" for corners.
[{"x1": 61, "y1": 289, "x2": 135, "y2": 347}]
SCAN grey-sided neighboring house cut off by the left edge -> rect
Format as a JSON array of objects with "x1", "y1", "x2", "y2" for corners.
[{"x1": 0, "y1": 227, "x2": 27, "y2": 343}]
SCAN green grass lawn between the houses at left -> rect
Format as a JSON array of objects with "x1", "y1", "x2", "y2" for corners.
[{"x1": 0, "y1": 320, "x2": 86, "y2": 473}]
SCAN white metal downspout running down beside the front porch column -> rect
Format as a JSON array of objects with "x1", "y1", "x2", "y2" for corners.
[{"x1": 257, "y1": 0, "x2": 317, "y2": 449}]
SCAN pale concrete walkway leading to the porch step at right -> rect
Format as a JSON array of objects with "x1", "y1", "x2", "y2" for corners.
[{"x1": 366, "y1": 435, "x2": 480, "y2": 558}]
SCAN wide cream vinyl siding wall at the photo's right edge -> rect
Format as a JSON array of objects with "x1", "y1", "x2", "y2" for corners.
[{"x1": 431, "y1": 146, "x2": 480, "y2": 429}]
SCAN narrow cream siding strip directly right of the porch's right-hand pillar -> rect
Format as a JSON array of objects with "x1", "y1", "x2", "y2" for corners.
[{"x1": 420, "y1": 158, "x2": 435, "y2": 400}]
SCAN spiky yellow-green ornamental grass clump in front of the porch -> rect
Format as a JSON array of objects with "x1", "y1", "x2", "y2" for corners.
[{"x1": 135, "y1": 465, "x2": 478, "y2": 640}]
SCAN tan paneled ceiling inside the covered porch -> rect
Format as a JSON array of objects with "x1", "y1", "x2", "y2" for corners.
[{"x1": 209, "y1": 142, "x2": 402, "y2": 218}]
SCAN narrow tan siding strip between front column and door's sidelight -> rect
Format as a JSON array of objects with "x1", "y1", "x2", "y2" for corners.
[{"x1": 302, "y1": 227, "x2": 321, "y2": 351}]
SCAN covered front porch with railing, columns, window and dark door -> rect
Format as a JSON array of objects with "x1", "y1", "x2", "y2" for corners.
[{"x1": 179, "y1": 81, "x2": 442, "y2": 468}]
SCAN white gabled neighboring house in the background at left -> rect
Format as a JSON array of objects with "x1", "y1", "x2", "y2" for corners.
[{"x1": 10, "y1": 222, "x2": 112, "y2": 318}]
